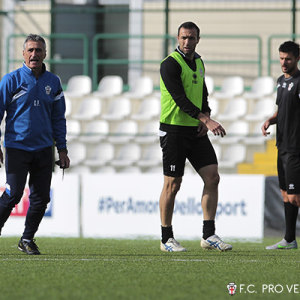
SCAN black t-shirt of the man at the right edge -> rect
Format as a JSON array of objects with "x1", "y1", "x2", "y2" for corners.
[{"x1": 276, "y1": 70, "x2": 300, "y2": 153}]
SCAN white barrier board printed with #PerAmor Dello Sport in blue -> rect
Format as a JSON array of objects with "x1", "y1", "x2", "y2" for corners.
[{"x1": 82, "y1": 174, "x2": 264, "y2": 239}]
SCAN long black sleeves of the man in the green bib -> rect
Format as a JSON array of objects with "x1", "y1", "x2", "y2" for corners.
[{"x1": 160, "y1": 56, "x2": 203, "y2": 119}]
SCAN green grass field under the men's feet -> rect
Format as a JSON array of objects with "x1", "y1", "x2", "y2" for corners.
[{"x1": 0, "y1": 237, "x2": 300, "y2": 300}]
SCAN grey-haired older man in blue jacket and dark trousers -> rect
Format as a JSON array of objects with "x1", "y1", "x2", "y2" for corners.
[{"x1": 0, "y1": 34, "x2": 70, "y2": 255}]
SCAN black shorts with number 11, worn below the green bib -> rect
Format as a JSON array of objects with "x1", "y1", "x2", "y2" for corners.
[{"x1": 160, "y1": 132, "x2": 218, "y2": 177}]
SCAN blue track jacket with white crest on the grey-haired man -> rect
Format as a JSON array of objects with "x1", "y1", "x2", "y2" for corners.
[{"x1": 0, "y1": 64, "x2": 66, "y2": 151}]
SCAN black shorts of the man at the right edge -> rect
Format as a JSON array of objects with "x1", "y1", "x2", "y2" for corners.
[{"x1": 277, "y1": 151, "x2": 300, "y2": 195}]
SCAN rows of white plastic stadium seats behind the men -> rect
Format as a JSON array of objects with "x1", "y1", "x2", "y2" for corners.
[{"x1": 65, "y1": 76, "x2": 276, "y2": 174}]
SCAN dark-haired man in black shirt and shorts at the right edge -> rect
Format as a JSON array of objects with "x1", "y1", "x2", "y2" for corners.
[{"x1": 262, "y1": 41, "x2": 300, "y2": 250}]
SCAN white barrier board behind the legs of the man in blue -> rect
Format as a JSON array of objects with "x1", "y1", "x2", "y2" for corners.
[{"x1": 1, "y1": 174, "x2": 80, "y2": 237}]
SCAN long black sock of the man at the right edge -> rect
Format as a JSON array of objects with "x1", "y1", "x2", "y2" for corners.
[{"x1": 284, "y1": 202, "x2": 299, "y2": 243}]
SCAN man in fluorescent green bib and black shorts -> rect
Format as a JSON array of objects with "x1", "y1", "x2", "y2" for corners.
[{"x1": 159, "y1": 22, "x2": 232, "y2": 252}]
